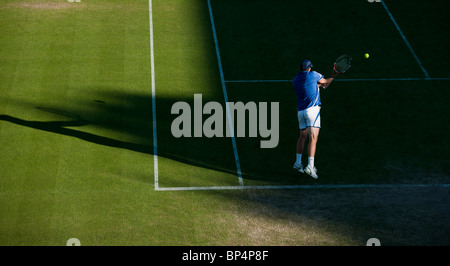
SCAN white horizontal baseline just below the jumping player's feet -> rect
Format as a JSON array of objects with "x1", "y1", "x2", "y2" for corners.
[{"x1": 157, "y1": 184, "x2": 450, "y2": 191}]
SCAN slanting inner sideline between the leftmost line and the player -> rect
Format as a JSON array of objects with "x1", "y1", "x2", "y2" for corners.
[{"x1": 208, "y1": 0, "x2": 244, "y2": 186}]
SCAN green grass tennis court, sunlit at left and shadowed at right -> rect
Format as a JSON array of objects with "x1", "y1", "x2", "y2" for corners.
[{"x1": 0, "y1": 0, "x2": 450, "y2": 246}]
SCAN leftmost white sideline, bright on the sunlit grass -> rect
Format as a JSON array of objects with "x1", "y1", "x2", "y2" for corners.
[{"x1": 148, "y1": 0, "x2": 159, "y2": 189}]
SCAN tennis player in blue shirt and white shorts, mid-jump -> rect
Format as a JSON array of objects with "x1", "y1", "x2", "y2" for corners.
[{"x1": 292, "y1": 59, "x2": 333, "y2": 179}]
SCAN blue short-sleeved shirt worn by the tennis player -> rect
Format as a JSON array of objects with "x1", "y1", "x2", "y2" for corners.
[{"x1": 292, "y1": 71, "x2": 323, "y2": 111}]
